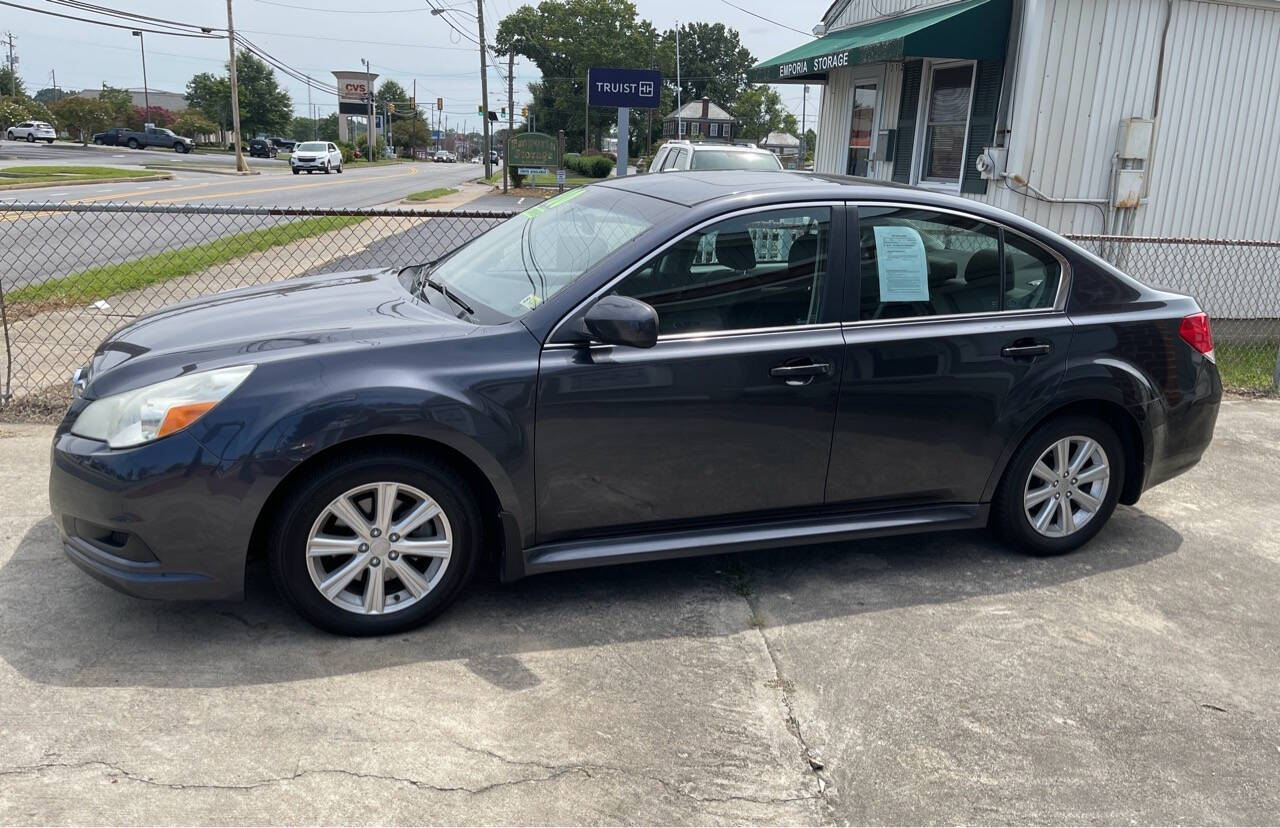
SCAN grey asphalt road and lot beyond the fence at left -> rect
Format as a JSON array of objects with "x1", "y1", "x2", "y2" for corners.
[{"x1": 0, "y1": 142, "x2": 481, "y2": 289}]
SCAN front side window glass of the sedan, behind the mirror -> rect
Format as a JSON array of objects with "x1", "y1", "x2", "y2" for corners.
[{"x1": 613, "y1": 207, "x2": 831, "y2": 335}]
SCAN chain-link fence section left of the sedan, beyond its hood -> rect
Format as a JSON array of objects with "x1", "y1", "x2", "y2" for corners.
[{"x1": 0, "y1": 203, "x2": 511, "y2": 418}]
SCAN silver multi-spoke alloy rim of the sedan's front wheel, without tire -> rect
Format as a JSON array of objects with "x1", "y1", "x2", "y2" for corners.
[{"x1": 307, "y1": 482, "x2": 453, "y2": 616}]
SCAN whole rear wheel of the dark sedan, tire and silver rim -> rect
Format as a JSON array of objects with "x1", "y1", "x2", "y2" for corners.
[{"x1": 991, "y1": 416, "x2": 1125, "y2": 555}]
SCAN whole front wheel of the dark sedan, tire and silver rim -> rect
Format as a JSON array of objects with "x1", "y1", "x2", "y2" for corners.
[{"x1": 269, "y1": 454, "x2": 480, "y2": 635}]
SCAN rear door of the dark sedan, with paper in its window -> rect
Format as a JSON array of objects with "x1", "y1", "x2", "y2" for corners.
[{"x1": 827, "y1": 205, "x2": 1073, "y2": 507}]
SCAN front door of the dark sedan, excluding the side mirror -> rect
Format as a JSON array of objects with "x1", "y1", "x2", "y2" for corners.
[{"x1": 535, "y1": 203, "x2": 844, "y2": 543}]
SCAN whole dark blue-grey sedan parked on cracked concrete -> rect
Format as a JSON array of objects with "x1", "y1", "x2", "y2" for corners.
[{"x1": 50, "y1": 171, "x2": 1221, "y2": 635}]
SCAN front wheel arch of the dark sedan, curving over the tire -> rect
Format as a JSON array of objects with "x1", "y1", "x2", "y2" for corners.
[{"x1": 247, "y1": 434, "x2": 509, "y2": 575}]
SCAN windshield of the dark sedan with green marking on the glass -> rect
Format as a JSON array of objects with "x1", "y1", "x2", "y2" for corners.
[{"x1": 426, "y1": 187, "x2": 680, "y2": 319}]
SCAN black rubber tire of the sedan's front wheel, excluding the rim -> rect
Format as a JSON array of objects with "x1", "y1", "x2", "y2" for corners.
[{"x1": 268, "y1": 452, "x2": 481, "y2": 636}]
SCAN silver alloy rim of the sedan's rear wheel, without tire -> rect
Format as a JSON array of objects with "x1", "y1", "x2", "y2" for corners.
[{"x1": 1023, "y1": 436, "x2": 1111, "y2": 537}]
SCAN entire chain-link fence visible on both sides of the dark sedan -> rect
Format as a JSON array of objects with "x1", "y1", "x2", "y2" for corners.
[{"x1": 0, "y1": 203, "x2": 1280, "y2": 417}]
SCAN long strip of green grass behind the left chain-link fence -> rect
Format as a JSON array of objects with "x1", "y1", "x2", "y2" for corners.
[{"x1": 5, "y1": 216, "x2": 365, "y2": 310}]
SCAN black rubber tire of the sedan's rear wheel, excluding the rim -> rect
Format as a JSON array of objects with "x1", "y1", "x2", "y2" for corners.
[{"x1": 989, "y1": 416, "x2": 1125, "y2": 557}]
